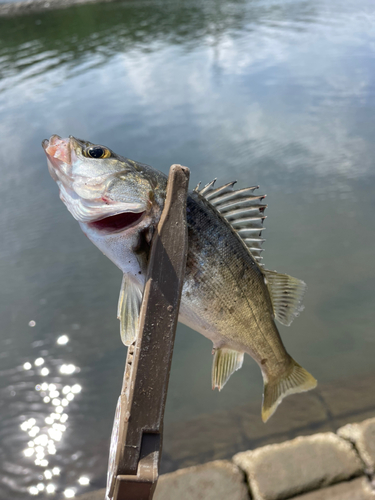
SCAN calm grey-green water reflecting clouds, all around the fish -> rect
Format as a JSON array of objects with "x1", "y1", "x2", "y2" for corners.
[{"x1": 0, "y1": 0, "x2": 375, "y2": 500}]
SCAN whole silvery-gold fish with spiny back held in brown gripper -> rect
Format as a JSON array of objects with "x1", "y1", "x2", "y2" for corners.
[{"x1": 42, "y1": 135, "x2": 317, "y2": 422}]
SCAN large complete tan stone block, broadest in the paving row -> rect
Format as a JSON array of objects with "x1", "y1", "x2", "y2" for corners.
[{"x1": 233, "y1": 432, "x2": 363, "y2": 500}]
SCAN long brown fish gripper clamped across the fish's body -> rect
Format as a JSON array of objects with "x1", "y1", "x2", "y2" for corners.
[{"x1": 106, "y1": 165, "x2": 190, "y2": 500}]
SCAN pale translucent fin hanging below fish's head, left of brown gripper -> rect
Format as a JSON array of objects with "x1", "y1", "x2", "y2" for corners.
[{"x1": 117, "y1": 274, "x2": 142, "y2": 345}]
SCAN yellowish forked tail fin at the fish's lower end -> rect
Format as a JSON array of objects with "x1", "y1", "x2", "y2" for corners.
[{"x1": 262, "y1": 358, "x2": 317, "y2": 422}]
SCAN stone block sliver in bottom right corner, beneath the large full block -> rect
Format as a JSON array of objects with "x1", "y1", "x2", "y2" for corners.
[{"x1": 293, "y1": 477, "x2": 375, "y2": 500}]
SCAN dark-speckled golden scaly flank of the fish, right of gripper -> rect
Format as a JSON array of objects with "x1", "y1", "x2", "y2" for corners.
[{"x1": 183, "y1": 194, "x2": 289, "y2": 360}]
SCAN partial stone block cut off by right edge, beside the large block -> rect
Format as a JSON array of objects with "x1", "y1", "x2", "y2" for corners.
[{"x1": 337, "y1": 418, "x2": 375, "y2": 475}]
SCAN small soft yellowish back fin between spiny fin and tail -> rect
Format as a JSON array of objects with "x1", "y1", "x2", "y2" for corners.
[{"x1": 263, "y1": 270, "x2": 306, "y2": 326}]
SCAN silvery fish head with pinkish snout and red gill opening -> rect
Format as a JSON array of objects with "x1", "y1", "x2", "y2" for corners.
[{"x1": 42, "y1": 135, "x2": 166, "y2": 273}]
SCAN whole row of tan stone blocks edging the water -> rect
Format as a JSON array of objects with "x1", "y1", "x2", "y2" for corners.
[{"x1": 77, "y1": 418, "x2": 375, "y2": 500}]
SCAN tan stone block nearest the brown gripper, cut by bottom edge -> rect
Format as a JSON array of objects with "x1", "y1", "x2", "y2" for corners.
[{"x1": 154, "y1": 460, "x2": 250, "y2": 500}]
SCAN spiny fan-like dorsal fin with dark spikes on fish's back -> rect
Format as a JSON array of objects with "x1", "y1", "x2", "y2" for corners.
[{"x1": 195, "y1": 179, "x2": 267, "y2": 267}]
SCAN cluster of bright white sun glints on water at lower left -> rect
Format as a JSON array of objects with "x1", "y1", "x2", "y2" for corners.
[{"x1": 20, "y1": 336, "x2": 90, "y2": 498}]
